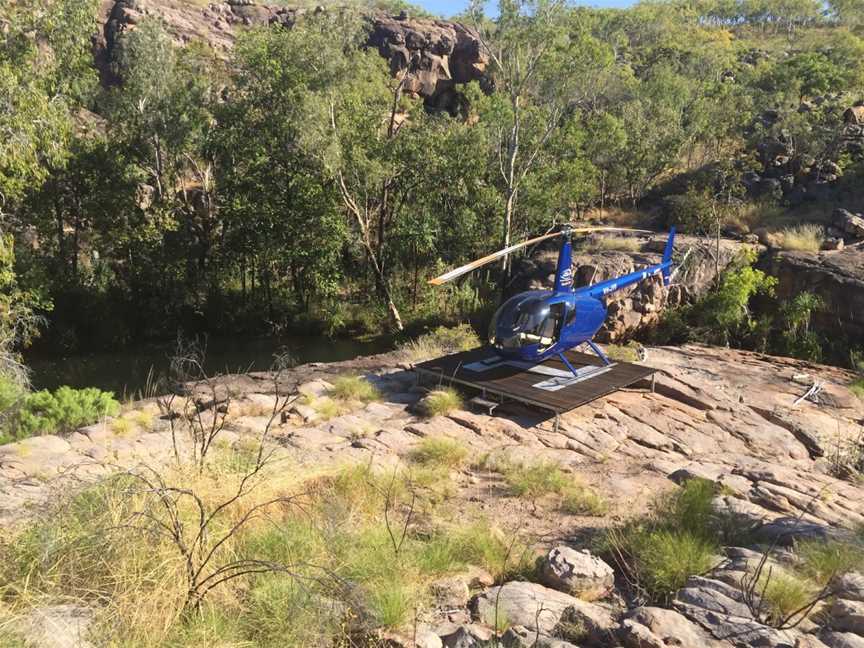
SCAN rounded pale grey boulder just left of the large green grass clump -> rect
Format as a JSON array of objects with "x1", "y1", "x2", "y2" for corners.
[{"x1": 540, "y1": 545, "x2": 615, "y2": 601}]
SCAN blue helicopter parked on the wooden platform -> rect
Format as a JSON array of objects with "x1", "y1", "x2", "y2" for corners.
[{"x1": 429, "y1": 226, "x2": 675, "y2": 377}]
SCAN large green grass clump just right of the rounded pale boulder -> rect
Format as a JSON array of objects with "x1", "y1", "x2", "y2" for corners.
[{"x1": 604, "y1": 479, "x2": 735, "y2": 603}]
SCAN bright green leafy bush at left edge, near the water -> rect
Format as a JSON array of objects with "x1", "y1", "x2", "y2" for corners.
[{"x1": 15, "y1": 386, "x2": 120, "y2": 439}]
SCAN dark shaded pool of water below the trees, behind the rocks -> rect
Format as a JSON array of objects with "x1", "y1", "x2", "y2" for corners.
[{"x1": 27, "y1": 336, "x2": 392, "y2": 397}]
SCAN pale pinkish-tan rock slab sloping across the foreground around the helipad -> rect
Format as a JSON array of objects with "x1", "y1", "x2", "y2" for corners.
[{"x1": 0, "y1": 346, "x2": 864, "y2": 648}]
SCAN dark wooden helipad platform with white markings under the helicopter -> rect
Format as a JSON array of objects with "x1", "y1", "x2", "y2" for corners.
[{"x1": 414, "y1": 348, "x2": 656, "y2": 415}]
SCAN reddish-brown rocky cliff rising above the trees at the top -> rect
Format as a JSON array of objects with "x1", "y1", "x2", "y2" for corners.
[{"x1": 95, "y1": 0, "x2": 487, "y2": 111}]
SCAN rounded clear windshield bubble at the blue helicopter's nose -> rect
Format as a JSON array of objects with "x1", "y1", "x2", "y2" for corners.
[{"x1": 490, "y1": 295, "x2": 564, "y2": 349}]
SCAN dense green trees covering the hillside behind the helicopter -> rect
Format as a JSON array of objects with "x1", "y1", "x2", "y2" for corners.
[{"x1": 0, "y1": 0, "x2": 864, "y2": 356}]
